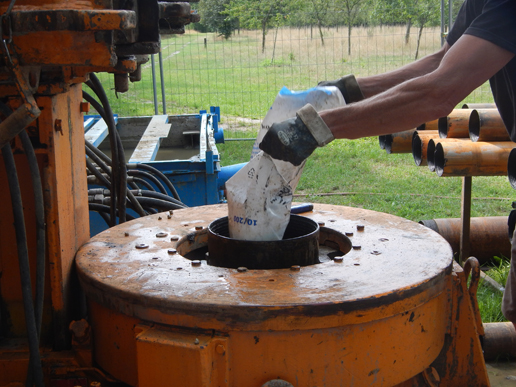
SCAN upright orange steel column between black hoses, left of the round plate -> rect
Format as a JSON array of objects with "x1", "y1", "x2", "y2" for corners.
[{"x1": 39, "y1": 84, "x2": 89, "y2": 349}]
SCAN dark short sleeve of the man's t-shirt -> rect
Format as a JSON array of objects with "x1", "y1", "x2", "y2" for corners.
[{"x1": 446, "y1": 0, "x2": 516, "y2": 54}]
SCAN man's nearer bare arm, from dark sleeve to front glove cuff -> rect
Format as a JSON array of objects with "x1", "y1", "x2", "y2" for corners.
[{"x1": 320, "y1": 35, "x2": 514, "y2": 139}]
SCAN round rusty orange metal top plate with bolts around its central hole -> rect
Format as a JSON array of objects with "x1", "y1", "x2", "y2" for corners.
[{"x1": 76, "y1": 204, "x2": 452, "y2": 329}]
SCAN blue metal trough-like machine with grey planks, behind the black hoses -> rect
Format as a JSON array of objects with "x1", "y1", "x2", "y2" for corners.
[{"x1": 84, "y1": 107, "x2": 244, "y2": 235}]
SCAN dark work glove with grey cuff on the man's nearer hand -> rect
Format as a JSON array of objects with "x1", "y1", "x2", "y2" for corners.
[{"x1": 260, "y1": 104, "x2": 335, "y2": 166}]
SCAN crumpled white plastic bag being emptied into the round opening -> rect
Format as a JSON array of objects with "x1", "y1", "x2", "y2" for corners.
[{"x1": 226, "y1": 86, "x2": 346, "y2": 241}]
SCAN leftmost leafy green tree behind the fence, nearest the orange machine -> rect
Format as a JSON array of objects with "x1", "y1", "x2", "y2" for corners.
[{"x1": 199, "y1": 0, "x2": 238, "y2": 39}]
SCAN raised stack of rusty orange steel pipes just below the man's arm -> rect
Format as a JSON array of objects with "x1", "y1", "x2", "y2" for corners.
[{"x1": 380, "y1": 104, "x2": 516, "y2": 178}]
